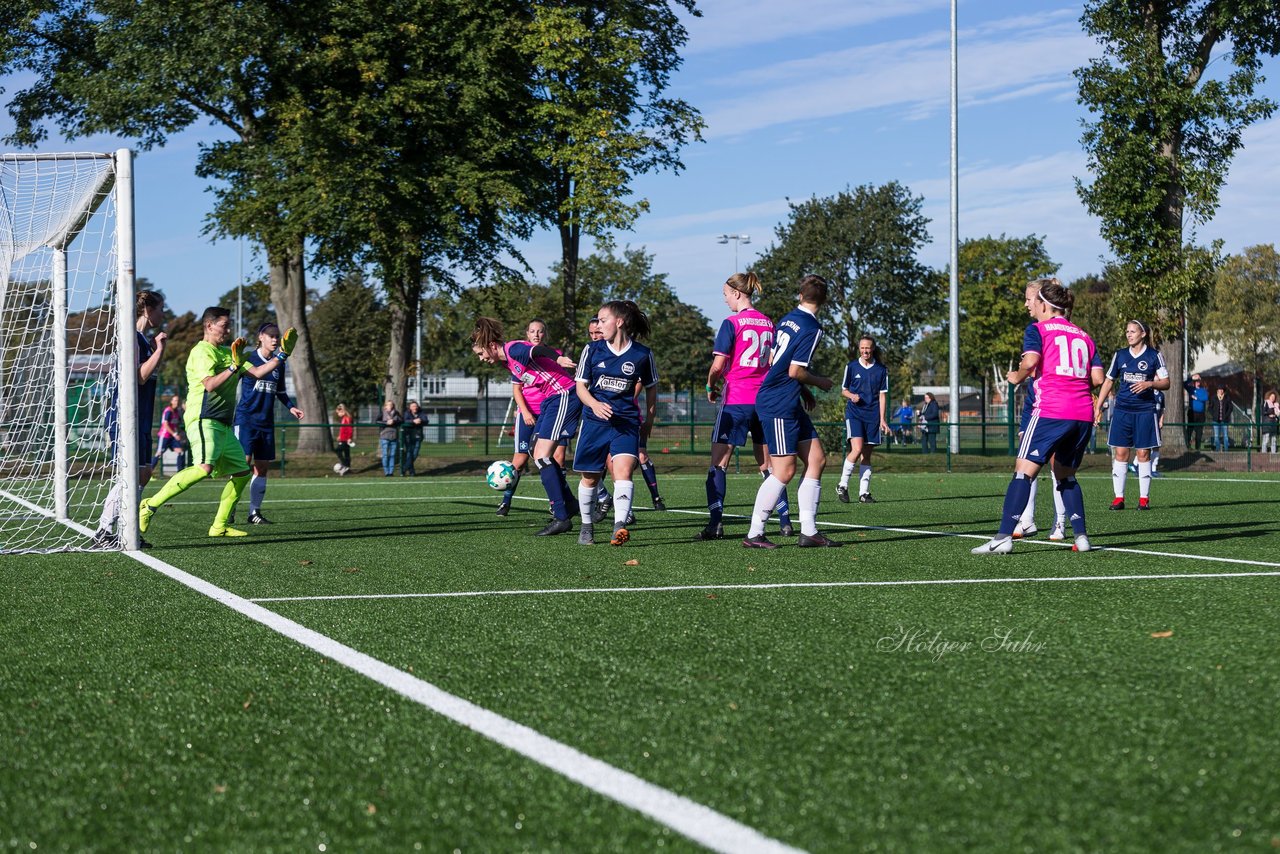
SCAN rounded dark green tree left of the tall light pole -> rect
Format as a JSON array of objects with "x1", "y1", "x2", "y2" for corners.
[{"x1": 756, "y1": 182, "x2": 941, "y2": 394}]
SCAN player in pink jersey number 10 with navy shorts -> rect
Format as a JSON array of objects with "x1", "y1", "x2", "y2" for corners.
[{"x1": 973, "y1": 282, "x2": 1105, "y2": 554}]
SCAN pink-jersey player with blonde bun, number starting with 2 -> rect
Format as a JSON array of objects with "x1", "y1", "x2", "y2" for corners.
[{"x1": 694, "y1": 273, "x2": 794, "y2": 540}]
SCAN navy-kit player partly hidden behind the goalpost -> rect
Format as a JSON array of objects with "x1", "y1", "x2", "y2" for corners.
[{"x1": 93, "y1": 291, "x2": 168, "y2": 548}]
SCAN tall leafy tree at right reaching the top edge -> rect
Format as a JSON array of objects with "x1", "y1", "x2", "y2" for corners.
[{"x1": 1075, "y1": 0, "x2": 1280, "y2": 442}]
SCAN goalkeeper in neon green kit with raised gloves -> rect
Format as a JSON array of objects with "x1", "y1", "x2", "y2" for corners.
[{"x1": 138, "y1": 306, "x2": 298, "y2": 536}]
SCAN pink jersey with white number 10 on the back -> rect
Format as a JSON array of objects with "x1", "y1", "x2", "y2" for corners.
[{"x1": 1023, "y1": 318, "x2": 1102, "y2": 421}]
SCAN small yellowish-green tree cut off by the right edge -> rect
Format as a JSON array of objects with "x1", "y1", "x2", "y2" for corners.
[{"x1": 1204, "y1": 243, "x2": 1280, "y2": 411}]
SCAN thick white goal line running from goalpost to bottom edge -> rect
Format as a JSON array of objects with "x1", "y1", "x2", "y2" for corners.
[{"x1": 125, "y1": 552, "x2": 799, "y2": 854}]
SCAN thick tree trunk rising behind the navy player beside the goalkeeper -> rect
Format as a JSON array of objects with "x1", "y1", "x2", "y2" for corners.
[{"x1": 268, "y1": 238, "x2": 333, "y2": 453}]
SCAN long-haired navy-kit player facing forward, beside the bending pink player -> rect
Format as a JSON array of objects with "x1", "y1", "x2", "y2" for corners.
[{"x1": 573, "y1": 300, "x2": 658, "y2": 545}]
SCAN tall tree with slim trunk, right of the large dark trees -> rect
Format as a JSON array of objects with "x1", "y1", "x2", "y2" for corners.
[{"x1": 520, "y1": 0, "x2": 704, "y2": 339}]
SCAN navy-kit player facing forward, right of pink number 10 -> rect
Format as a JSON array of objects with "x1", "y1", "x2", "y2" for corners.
[{"x1": 1093, "y1": 320, "x2": 1170, "y2": 510}]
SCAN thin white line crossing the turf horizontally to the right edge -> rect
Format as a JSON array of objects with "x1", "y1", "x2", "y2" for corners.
[{"x1": 250, "y1": 571, "x2": 1280, "y2": 602}]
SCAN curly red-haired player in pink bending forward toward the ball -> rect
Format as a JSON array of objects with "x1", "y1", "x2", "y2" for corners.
[{"x1": 471, "y1": 318, "x2": 582, "y2": 536}]
